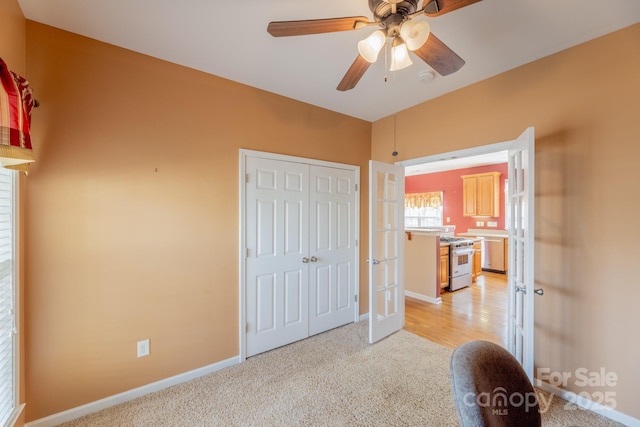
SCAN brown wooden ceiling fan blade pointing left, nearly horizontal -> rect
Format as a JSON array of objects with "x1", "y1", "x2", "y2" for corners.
[{"x1": 267, "y1": 16, "x2": 370, "y2": 37}]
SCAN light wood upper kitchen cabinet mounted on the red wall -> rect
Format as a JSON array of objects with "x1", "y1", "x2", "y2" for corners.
[{"x1": 462, "y1": 172, "x2": 500, "y2": 217}]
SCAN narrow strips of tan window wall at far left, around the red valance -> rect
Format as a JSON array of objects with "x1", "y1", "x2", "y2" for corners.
[{"x1": 0, "y1": 0, "x2": 29, "y2": 426}]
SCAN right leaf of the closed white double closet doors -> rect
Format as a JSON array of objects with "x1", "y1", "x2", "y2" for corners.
[{"x1": 309, "y1": 165, "x2": 357, "y2": 335}]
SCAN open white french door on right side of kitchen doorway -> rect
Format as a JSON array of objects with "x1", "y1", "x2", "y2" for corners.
[{"x1": 507, "y1": 128, "x2": 541, "y2": 383}]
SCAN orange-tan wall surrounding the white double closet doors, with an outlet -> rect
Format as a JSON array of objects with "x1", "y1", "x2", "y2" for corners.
[{"x1": 26, "y1": 21, "x2": 371, "y2": 420}]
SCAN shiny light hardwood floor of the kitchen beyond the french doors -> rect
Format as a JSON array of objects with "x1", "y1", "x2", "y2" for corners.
[{"x1": 404, "y1": 271, "x2": 508, "y2": 348}]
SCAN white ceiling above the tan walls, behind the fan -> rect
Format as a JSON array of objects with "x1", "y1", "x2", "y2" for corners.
[{"x1": 19, "y1": 0, "x2": 640, "y2": 121}]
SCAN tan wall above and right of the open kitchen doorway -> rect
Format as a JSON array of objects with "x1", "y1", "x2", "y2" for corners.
[{"x1": 372, "y1": 24, "x2": 640, "y2": 418}]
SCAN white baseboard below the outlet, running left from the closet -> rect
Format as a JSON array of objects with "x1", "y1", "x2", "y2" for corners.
[{"x1": 25, "y1": 356, "x2": 240, "y2": 427}]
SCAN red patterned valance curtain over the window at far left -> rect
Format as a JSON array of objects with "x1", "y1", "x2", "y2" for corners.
[{"x1": 0, "y1": 58, "x2": 36, "y2": 172}]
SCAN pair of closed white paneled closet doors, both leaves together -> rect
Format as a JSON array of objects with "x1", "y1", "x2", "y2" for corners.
[{"x1": 240, "y1": 153, "x2": 358, "y2": 356}]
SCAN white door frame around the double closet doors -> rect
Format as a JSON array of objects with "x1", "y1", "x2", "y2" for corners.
[{"x1": 238, "y1": 148, "x2": 360, "y2": 362}]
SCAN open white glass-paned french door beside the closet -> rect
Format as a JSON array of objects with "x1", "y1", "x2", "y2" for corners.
[{"x1": 367, "y1": 160, "x2": 404, "y2": 344}]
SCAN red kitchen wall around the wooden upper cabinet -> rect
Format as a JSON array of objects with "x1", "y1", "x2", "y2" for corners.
[{"x1": 404, "y1": 163, "x2": 507, "y2": 233}]
